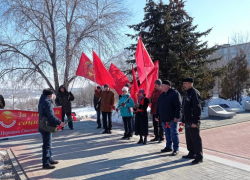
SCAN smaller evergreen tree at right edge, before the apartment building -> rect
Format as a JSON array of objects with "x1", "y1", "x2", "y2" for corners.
[{"x1": 220, "y1": 50, "x2": 250, "y2": 102}]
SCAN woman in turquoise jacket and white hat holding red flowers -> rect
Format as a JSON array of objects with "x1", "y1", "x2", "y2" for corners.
[{"x1": 116, "y1": 87, "x2": 135, "y2": 140}]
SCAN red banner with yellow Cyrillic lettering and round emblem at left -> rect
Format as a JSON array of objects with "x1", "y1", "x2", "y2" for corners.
[{"x1": 0, "y1": 107, "x2": 62, "y2": 138}]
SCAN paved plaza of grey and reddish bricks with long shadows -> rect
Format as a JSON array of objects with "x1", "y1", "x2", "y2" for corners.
[{"x1": 0, "y1": 115, "x2": 250, "y2": 180}]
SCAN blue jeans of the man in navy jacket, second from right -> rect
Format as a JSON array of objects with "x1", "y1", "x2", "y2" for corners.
[{"x1": 162, "y1": 122, "x2": 179, "y2": 151}]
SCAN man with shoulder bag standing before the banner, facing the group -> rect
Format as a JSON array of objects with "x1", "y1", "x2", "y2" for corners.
[{"x1": 38, "y1": 89, "x2": 65, "y2": 169}]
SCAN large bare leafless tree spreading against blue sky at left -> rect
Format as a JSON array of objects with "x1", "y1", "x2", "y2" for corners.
[{"x1": 0, "y1": 0, "x2": 129, "y2": 90}]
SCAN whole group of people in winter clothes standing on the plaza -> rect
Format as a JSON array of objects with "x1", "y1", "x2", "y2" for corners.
[{"x1": 37, "y1": 78, "x2": 203, "y2": 169}]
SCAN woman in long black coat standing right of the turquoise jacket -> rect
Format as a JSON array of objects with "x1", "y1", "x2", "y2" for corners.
[{"x1": 135, "y1": 89, "x2": 149, "y2": 145}]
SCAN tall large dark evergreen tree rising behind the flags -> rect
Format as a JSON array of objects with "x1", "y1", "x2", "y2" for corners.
[{"x1": 127, "y1": 0, "x2": 222, "y2": 99}]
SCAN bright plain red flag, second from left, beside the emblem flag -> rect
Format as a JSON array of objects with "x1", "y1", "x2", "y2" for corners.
[{"x1": 93, "y1": 51, "x2": 115, "y2": 89}]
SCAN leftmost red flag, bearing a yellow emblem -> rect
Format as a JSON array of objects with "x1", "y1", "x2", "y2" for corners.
[{"x1": 76, "y1": 53, "x2": 95, "y2": 81}]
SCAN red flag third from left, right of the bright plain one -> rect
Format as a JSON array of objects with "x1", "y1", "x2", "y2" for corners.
[{"x1": 109, "y1": 63, "x2": 129, "y2": 95}]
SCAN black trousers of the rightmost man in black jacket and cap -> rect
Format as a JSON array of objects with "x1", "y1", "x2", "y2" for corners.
[{"x1": 185, "y1": 127, "x2": 203, "y2": 160}]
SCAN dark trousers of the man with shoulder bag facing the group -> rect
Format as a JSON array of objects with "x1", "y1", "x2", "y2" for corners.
[{"x1": 41, "y1": 133, "x2": 52, "y2": 165}]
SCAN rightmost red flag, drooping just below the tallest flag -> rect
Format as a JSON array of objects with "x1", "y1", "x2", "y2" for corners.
[{"x1": 139, "y1": 61, "x2": 159, "y2": 97}]
